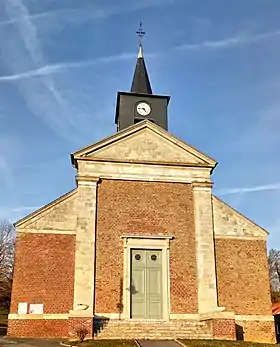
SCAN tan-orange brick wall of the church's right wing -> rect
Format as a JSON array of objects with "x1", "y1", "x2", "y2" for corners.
[{"x1": 215, "y1": 239, "x2": 271, "y2": 315}]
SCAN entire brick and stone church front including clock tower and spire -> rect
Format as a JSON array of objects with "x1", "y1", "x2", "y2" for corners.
[{"x1": 8, "y1": 45, "x2": 275, "y2": 342}]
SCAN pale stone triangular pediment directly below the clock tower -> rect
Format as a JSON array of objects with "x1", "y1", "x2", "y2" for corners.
[{"x1": 72, "y1": 121, "x2": 216, "y2": 167}]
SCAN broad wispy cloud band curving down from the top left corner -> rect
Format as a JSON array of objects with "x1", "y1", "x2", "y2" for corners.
[{"x1": 2, "y1": 0, "x2": 95, "y2": 141}]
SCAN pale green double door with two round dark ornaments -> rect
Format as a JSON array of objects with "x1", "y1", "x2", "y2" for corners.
[{"x1": 130, "y1": 249, "x2": 162, "y2": 319}]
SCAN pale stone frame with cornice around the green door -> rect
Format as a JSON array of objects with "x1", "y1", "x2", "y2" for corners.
[{"x1": 122, "y1": 235, "x2": 173, "y2": 321}]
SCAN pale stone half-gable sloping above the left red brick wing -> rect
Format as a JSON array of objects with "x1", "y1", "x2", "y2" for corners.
[{"x1": 14, "y1": 189, "x2": 77, "y2": 232}]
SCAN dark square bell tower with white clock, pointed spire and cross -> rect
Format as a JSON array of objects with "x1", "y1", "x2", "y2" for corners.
[{"x1": 115, "y1": 23, "x2": 170, "y2": 131}]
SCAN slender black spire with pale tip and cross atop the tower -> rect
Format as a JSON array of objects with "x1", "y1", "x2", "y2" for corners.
[{"x1": 130, "y1": 23, "x2": 153, "y2": 94}]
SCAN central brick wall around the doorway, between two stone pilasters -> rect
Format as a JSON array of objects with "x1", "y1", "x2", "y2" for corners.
[{"x1": 95, "y1": 180, "x2": 197, "y2": 313}]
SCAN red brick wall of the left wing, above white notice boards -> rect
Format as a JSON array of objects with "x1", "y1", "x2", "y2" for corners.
[{"x1": 11, "y1": 234, "x2": 75, "y2": 316}]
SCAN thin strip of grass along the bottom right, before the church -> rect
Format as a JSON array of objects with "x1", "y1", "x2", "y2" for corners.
[{"x1": 179, "y1": 339, "x2": 275, "y2": 347}]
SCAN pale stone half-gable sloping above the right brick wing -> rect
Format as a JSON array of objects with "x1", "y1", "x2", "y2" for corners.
[{"x1": 212, "y1": 195, "x2": 268, "y2": 239}]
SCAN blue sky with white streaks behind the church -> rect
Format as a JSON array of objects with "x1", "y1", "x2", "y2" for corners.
[{"x1": 0, "y1": 0, "x2": 280, "y2": 249}]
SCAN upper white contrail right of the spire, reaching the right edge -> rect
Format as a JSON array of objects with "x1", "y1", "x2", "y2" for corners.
[{"x1": 174, "y1": 30, "x2": 280, "y2": 51}]
